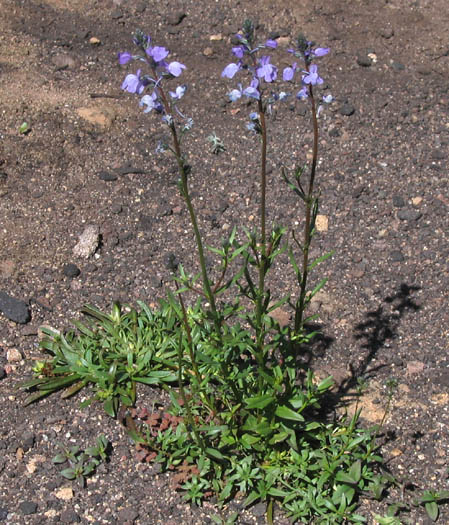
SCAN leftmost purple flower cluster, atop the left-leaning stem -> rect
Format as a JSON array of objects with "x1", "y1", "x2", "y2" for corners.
[{"x1": 118, "y1": 31, "x2": 186, "y2": 122}]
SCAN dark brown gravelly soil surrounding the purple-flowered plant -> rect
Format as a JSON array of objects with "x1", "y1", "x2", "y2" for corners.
[{"x1": 0, "y1": 0, "x2": 449, "y2": 525}]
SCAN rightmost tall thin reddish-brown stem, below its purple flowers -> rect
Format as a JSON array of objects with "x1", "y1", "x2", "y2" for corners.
[{"x1": 295, "y1": 80, "x2": 318, "y2": 334}]
